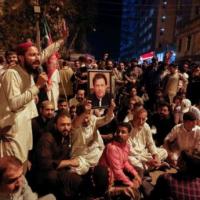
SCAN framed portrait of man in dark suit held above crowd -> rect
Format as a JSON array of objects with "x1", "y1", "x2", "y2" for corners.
[{"x1": 88, "y1": 70, "x2": 112, "y2": 108}]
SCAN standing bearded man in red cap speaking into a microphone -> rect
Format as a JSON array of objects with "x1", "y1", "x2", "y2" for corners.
[{"x1": 0, "y1": 42, "x2": 48, "y2": 166}]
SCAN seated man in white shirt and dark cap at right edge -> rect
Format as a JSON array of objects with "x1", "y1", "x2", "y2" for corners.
[{"x1": 164, "y1": 112, "x2": 200, "y2": 166}]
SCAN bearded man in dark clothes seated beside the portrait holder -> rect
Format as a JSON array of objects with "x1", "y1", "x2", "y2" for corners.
[{"x1": 35, "y1": 112, "x2": 82, "y2": 199}]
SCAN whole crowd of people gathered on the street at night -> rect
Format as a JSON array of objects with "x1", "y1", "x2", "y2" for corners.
[{"x1": 0, "y1": 34, "x2": 200, "y2": 200}]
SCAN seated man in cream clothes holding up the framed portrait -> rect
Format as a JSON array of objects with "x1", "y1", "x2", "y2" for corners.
[{"x1": 72, "y1": 102, "x2": 115, "y2": 175}]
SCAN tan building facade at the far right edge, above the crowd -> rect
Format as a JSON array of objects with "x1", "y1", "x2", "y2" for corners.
[{"x1": 176, "y1": 0, "x2": 200, "y2": 62}]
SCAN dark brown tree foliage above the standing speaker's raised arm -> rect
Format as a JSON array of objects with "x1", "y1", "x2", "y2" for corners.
[{"x1": 0, "y1": 0, "x2": 96, "y2": 50}]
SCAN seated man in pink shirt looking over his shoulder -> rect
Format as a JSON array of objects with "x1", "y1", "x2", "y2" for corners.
[{"x1": 99, "y1": 122, "x2": 141, "y2": 188}]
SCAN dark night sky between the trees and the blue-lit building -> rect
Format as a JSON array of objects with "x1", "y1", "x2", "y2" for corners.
[{"x1": 89, "y1": 0, "x2": 121, "y2": 59}]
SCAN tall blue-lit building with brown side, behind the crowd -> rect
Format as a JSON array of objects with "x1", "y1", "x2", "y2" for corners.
[{"x1": 121, "y1": 0, "x2": 177, "y2": 60}]
